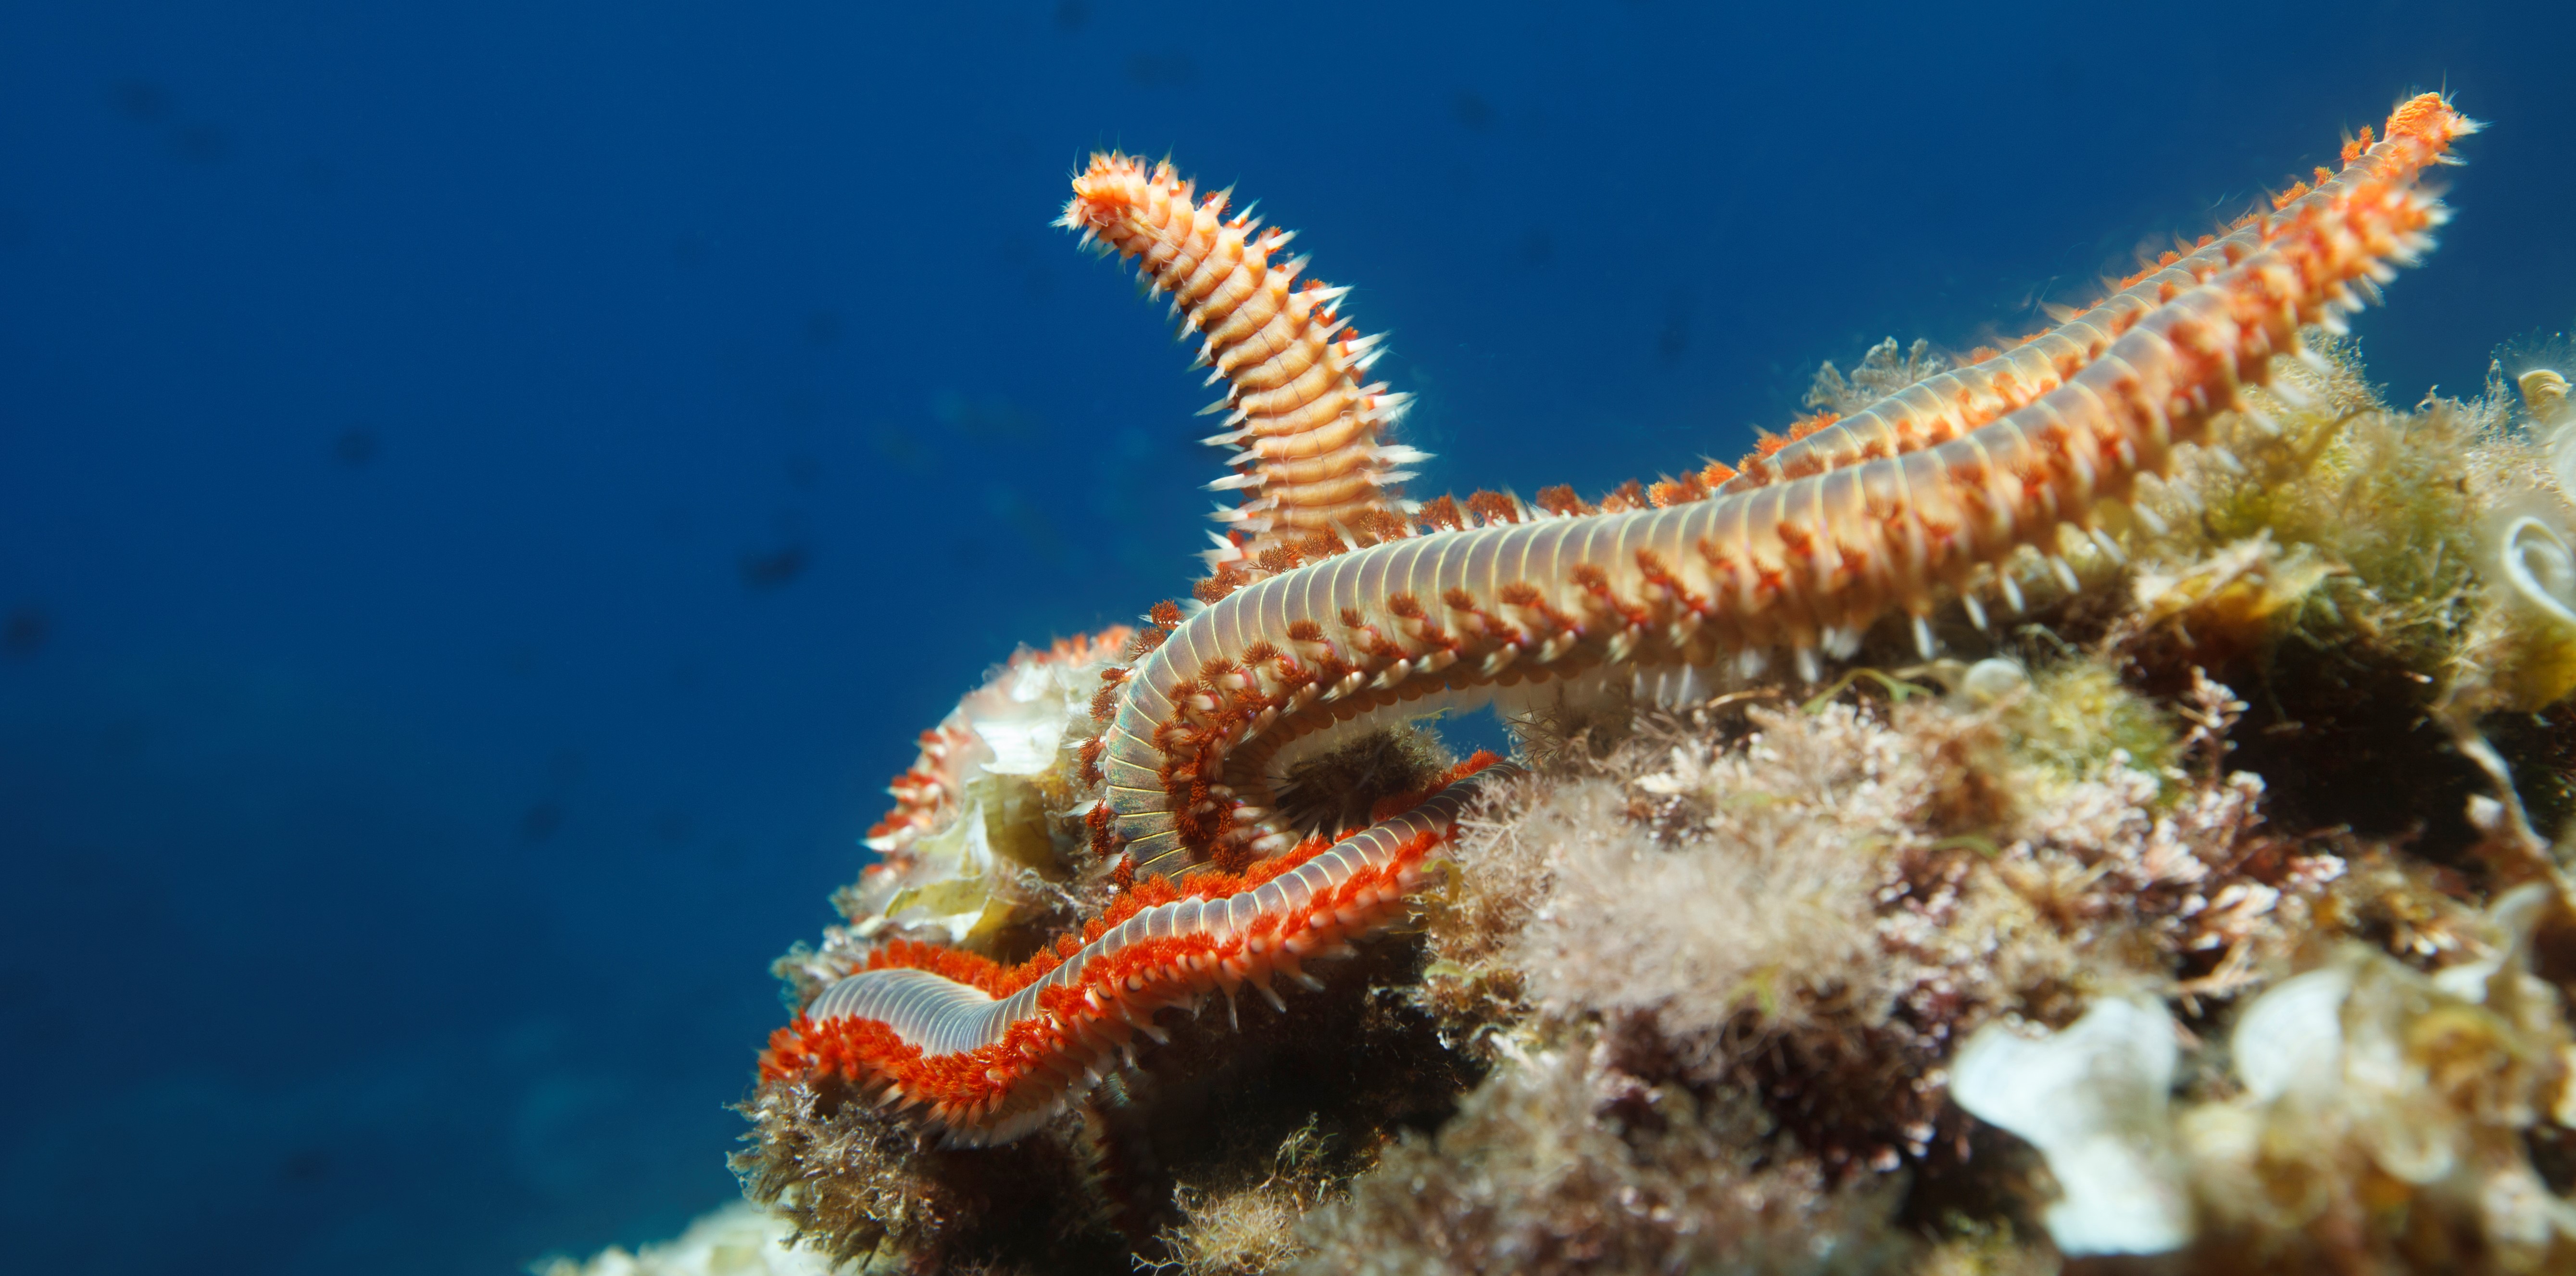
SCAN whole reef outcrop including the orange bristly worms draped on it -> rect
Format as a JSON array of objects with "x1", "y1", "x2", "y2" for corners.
[{"x1": 690, "y1": 95, "x2": 2576, "y2": 1274}]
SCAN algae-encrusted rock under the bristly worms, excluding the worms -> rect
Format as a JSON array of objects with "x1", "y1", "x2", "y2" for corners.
[{"x1": 690, "y1": 338, "x2": 2576, "y2": 1274}]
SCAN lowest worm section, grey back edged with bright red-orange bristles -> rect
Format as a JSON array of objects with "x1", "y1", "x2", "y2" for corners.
[{"x1": 760, "y1": 766, "x2": 1515, "y2": 1145}]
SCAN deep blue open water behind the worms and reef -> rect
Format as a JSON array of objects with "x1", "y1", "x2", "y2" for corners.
[{"x1": 0, "y1": 0, "x2": 2576, "y2": 1274}]
